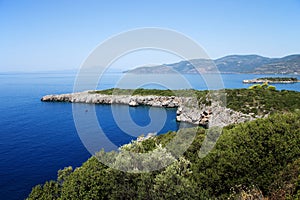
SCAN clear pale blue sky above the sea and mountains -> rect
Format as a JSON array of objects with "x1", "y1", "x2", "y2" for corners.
[{"x1": 0, "y1": 0, "x2": 300, "y2": 71}]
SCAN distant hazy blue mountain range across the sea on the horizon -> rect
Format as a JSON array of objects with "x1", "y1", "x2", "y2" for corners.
[{"x1": 124, "y1": 54, "x2": 300, "y2": 74}]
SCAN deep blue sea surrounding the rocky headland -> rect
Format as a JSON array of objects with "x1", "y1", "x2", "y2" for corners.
[{"x1": 0, "y1": 72, "x2": 300, "y2": 200}]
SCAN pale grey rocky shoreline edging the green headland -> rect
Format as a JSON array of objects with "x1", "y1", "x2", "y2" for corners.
[{"x1": 41, "y1": 91, "x2": 255, "y2": 127}]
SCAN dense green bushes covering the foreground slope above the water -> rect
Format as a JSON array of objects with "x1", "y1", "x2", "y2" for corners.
[{"x1": 28, "y1": 111, "x2": 300, "y2": 199}]
